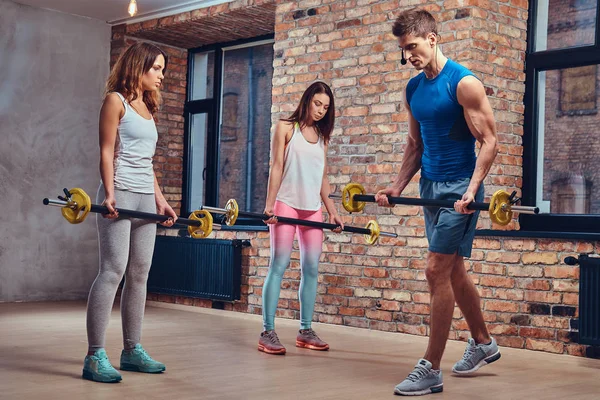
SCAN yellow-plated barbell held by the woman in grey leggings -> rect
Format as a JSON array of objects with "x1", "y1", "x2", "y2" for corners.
[{"x1": 44, "y1": 188, "x2": 221, "y2": 239}]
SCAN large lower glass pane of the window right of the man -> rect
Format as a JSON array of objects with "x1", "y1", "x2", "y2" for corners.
[{"x1": 537, "y1": 65, "x2": 600, "y2": 214}]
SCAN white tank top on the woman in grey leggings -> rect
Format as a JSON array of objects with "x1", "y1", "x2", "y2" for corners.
[{"x1": 114, "y1": 92, "x2": 158, "y2": 194}]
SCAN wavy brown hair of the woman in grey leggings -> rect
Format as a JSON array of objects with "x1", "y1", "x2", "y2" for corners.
[{"x1": 105, "y1": 42, "x2": 168, "y2": 119}]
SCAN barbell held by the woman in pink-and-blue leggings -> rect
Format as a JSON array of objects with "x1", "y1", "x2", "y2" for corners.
[{"x1": 202, "y1": 199, "x2": 398, "y2": 244}]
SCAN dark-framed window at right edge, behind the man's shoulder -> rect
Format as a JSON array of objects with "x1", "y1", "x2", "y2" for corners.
[{"x1": 520, "y1": 0, "x2": 600, "y2": 233}]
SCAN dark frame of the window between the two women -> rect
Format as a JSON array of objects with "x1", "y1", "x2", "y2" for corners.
[{"x1": 181, "y1": 34, "x2": 275, "y2": 231}]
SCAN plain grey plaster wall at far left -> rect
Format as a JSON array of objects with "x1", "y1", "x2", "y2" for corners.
[{"x1": 0, "y1": 0, "x2": 110, "y2": 302}]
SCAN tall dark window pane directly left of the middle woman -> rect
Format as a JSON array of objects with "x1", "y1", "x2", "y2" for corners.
[{"x1": 218, "y1": 43, "x2": 273, "y2": 212}]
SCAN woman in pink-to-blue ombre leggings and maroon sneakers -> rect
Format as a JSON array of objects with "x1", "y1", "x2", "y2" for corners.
[{"x1": 258, "y1": 82, "x2": 344, "y2": 354}]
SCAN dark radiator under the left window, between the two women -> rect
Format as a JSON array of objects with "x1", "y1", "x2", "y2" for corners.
[{"x1": 148, "y1": 236, "x2": 245, "y2": 301}]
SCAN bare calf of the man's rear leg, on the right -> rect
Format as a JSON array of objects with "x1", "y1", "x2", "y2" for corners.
[{"x1": 451, "y1": 254, "x2": 492, "y2": 344}]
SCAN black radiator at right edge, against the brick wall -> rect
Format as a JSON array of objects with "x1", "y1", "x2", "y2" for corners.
[{"x1": 565, "y1": 254, "x2": 600, "y2": 346}]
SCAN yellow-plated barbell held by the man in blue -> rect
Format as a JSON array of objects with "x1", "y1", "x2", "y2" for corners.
[{"x1": 329, "y1": 183, "x2": 540, "y2": 225}]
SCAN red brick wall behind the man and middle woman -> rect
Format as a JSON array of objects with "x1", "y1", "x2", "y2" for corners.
[{"x1": 113, "y1": 0, "x2": 600, "y2": 355}]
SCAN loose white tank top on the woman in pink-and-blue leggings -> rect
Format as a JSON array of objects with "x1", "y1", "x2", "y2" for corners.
[{"x1": 277, "y1": 123, "x2": 325, "y2": 211}]
